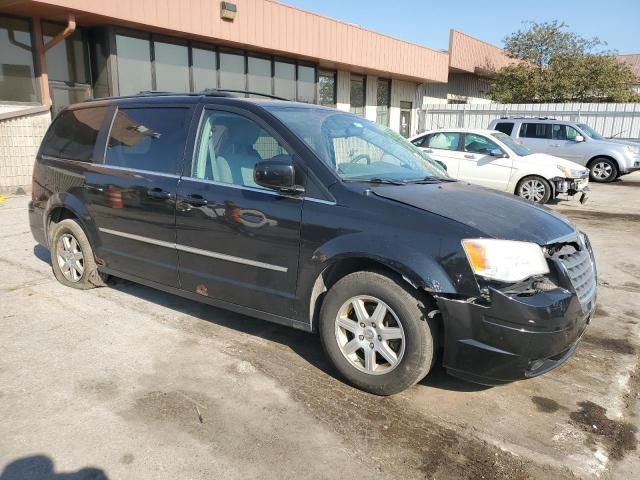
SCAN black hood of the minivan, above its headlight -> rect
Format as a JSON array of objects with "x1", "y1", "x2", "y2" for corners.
[{"x1": 371, "y1": 182, "x2": 576, "y2": 245}]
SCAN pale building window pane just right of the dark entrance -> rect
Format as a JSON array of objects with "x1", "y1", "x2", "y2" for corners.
[{"x1": 116, "y1": 35, "x2": 153, "y2": 95}]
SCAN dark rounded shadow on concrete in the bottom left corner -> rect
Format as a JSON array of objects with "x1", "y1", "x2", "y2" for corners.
[{"x1": 0, "y1": 455, "x2": 108, "y2": 480}]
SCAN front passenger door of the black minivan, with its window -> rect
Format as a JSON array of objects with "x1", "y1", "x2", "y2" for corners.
[{"x1": 176, "y1": 107, "x2": 302, "y2": 317}]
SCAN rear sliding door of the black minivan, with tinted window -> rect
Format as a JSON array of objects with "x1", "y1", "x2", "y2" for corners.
[{"x1": 84, "y1": 106, "x2": 192, "y2": 287}]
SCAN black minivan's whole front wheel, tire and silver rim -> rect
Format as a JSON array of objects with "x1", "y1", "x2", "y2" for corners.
[{"x1": 319, "y1": 271, "x2": 437, "y2": 395}]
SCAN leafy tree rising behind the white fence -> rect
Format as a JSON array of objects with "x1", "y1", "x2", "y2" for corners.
[{"x1": 490, "y1": 21, "x2": 640, "y2": 103}]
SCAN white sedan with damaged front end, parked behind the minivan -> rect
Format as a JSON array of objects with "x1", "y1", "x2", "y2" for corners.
[{"x1": 410, "y1": 129, "x2": 589, "y2": 203}]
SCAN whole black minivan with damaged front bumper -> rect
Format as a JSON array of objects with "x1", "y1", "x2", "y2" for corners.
[{"x1": 29, "y1": 91, "x2": 596, "y2": 395}]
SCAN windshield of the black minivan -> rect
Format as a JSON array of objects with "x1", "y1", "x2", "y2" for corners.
[{"x1": 265, "y1": 105, "x2": 449, "y2": 182}]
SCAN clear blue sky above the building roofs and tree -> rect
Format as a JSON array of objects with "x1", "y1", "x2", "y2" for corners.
[{"x1": 281, "y1": 0, "x2": 640, "y2": 53}]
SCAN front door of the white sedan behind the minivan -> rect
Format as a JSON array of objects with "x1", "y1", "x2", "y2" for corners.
[{"x1": 458, "y1": 133, "x2": 513, "y2": 191}]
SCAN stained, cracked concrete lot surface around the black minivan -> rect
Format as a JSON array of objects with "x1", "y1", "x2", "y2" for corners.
[{"x1": 0, "y1": 173, "x2": 640, "y2": 480}]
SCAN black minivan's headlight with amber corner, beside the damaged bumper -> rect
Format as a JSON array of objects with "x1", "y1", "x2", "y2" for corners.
[{"x1": 462, "y1": 238, "x2": 549, "y2": 282}]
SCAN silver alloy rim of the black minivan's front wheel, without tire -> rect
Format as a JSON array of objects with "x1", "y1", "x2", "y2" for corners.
[{"x1": 335, "y1": 295, "x2": 405, "y2": 375}]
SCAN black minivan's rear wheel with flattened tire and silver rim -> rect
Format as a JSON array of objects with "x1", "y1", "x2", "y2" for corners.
[{"x1": 49, "y1": 219, "x2": 107, "y2": 290}]
